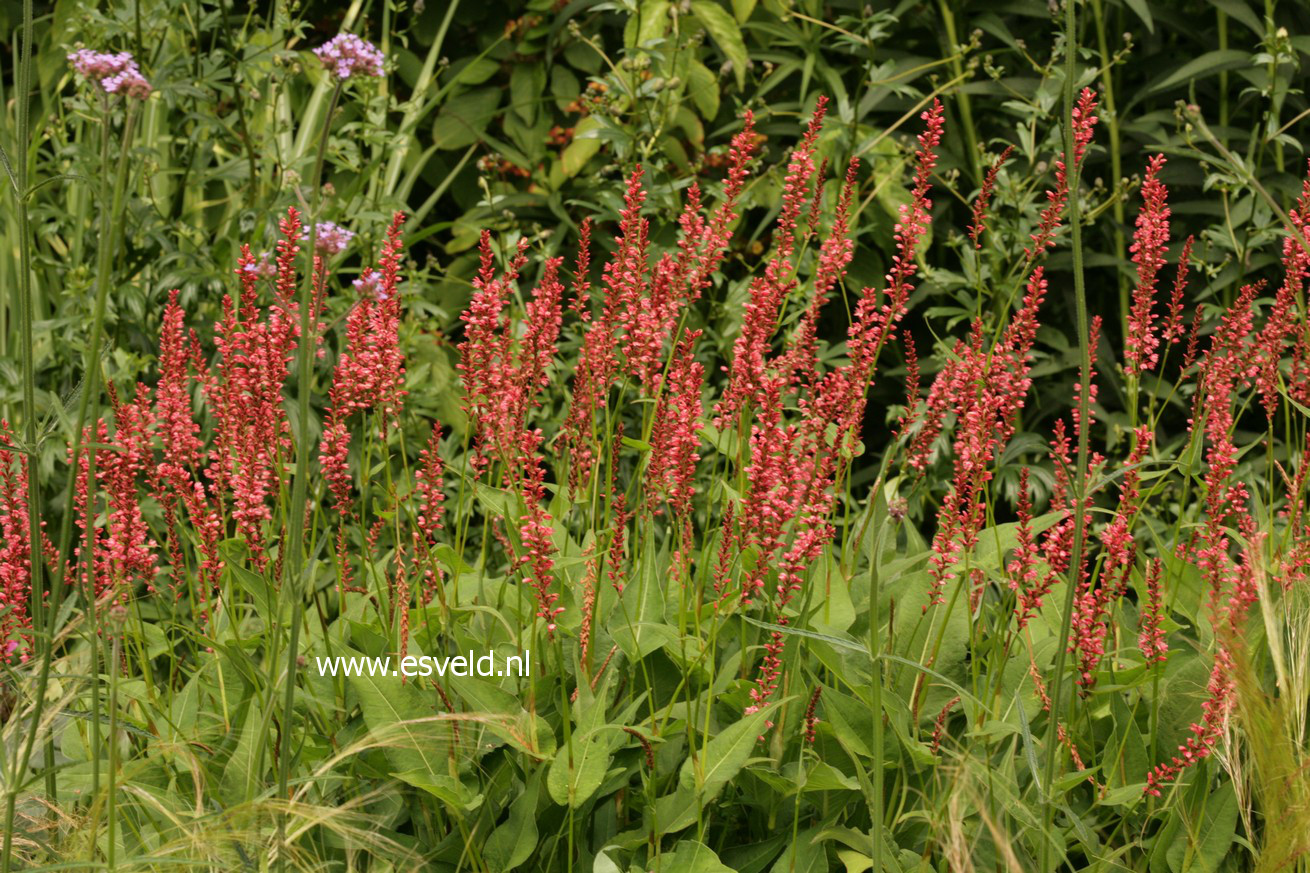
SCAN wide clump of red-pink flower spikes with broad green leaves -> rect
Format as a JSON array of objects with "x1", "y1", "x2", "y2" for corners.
[{"x1": 0, "y1": 68, "x2": 1310, "y2": 866}]
